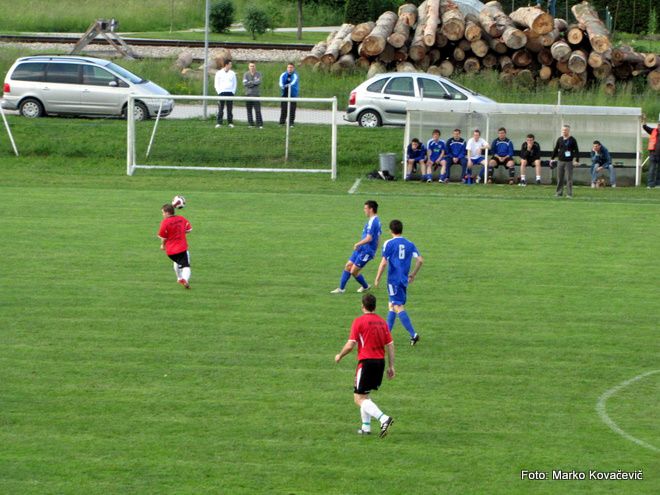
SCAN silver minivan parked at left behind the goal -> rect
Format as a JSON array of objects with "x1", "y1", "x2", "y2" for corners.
[{"x1": 1, "y1": 56, "x2": 174, "y2": 120}]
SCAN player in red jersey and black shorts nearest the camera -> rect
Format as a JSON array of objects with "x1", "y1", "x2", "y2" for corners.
[{"x1": 335, "y1": 294, "x2": 394, "y2": 438}]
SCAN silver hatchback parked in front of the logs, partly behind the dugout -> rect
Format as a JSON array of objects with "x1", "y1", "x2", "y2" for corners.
[{"x1": 344, "y1": 72, "x2": 495, "y2": 127}]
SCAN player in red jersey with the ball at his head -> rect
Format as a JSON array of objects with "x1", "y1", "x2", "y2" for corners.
[{"x1": 158, "y1": 203, "x2": 192, "y2": 289}]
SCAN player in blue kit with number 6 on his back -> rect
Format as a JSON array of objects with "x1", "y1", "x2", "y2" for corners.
[{"x1": 374, "y1": 220, "x2": 424, "y2": 345}]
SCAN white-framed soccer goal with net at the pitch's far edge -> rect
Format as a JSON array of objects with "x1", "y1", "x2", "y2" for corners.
[{"x1": 126, "y1": 95, "x2": 338, "y2": 180}]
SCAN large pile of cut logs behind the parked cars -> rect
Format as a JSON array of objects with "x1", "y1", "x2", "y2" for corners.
[{"x1": 302, "y1": 0, "x2": 660, "y2": 94}]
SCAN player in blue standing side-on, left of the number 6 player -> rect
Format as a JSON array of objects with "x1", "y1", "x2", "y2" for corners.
[{"x1": 330, "y1": 200, "x2": 381, "y2": 294}]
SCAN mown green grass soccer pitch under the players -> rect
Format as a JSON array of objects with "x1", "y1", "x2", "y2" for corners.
[{"x1": 0, "y1": 114, "x2": 660, "y2": 494}]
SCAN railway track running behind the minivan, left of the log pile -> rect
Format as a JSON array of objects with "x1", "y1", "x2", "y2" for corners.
[{"x1": 0, "y1": 34, "x2": 314, "y2": 51}]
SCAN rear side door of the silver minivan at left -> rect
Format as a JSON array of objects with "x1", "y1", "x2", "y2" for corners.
[{"x1": 42, "y1": 62, "x2": 80, "y2": 113}]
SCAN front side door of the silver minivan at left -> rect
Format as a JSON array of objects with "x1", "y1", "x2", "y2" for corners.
[{"x1": 81, "y1": 65, "x2": 130, "y2": 115}]
